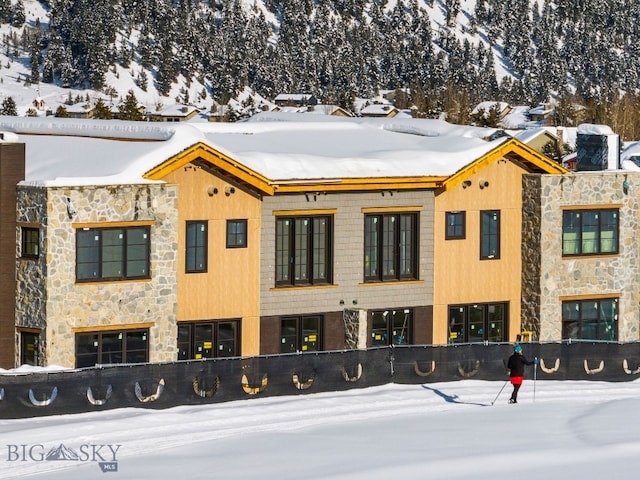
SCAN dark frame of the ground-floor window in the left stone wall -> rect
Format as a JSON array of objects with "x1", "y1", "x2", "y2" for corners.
[{"x1": 74, "y1": 328, "x2": 150, "y2": 368}]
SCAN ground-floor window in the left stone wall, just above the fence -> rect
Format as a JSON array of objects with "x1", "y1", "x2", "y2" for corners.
[{"x1": 76, "y1": 329, "x2": 149, "y2": 368}]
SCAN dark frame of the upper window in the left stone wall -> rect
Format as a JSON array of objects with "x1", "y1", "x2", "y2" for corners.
[{"x1": 76, "y1": 225, "x2": 151, "y2": 283}]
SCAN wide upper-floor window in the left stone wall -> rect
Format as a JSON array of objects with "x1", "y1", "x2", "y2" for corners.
[{"x1": 76, "y1": 227, "x2": 150, "y2": 282}]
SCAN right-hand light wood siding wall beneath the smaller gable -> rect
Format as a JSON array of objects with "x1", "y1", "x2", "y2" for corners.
[{"x1": 433, "y1": 159, "x2": 526, "y2": 344}]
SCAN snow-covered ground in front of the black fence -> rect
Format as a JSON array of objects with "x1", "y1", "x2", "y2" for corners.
[{"x1": 0, "y1": 380, "x2": 640, "y2": 480}]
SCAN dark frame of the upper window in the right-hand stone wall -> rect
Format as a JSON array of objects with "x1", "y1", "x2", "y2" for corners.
[{"x1": 562, "y1": 207, "x2": 620, "y2": 257}]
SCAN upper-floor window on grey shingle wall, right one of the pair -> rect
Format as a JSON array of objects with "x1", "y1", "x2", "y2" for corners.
[{"x1": 364, "y1": 213, "x2": 418, "y2": 282}]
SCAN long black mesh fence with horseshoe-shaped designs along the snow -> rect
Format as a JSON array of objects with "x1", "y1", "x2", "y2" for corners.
[{"x1": 0, "y1": 342, "x2": 640, "y2": 418}]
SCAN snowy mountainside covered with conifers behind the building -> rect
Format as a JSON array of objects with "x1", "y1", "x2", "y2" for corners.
[{"x1": 0, "y1": 0, "x2": 640, "y2": 136}]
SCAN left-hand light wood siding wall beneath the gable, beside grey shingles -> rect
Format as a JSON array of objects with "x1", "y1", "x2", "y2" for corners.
[{"x1": 163, "y1": 164, "x2": 260, "y2": 355}]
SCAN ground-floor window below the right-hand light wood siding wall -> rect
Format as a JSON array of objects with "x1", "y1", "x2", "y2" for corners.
[{"x1": 449, "y1": 303, "x2": 509, "y2": 343}]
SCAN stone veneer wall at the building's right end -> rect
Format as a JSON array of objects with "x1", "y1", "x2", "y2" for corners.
[{"x1": 523, "y1": 171, "x2": 640, "y2": 342}]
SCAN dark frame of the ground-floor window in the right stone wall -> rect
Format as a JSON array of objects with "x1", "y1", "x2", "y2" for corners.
[{"x1": 562, "y1": 297, "x2": 620, "y2": 342}]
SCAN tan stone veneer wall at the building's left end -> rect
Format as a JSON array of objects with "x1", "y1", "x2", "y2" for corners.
[{"x1": 16, "y1": 184, "x2": 179, "y2": 367}]
